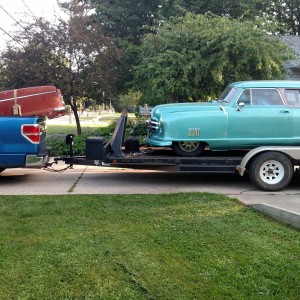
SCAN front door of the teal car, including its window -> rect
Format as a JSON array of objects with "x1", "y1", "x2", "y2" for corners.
[{"x1": 228, "y1": 88, "x2": 293, "y2": 149}]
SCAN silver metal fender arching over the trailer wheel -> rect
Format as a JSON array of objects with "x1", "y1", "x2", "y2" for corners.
[{"x1": 236, "y1": 146, "x2": 300, "y2": 176}]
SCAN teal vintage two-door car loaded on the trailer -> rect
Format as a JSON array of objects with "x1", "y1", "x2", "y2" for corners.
[{"x1": 146, "y1": 80, "x2": 300, "y2": 156}]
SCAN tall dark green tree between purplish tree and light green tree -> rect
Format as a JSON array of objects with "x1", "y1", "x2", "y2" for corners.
[{"x1": 91, "y1": 0, "x2": 162, "y2": 93}]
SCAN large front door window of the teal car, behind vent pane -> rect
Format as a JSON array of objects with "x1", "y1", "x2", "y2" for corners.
[{"x1": 251, "y1": 89, "x2": 284, "y2": 105}]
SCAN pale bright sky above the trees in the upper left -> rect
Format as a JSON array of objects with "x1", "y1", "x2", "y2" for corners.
[{"x1": 0, "y1": 0, "x2": 63, "y2": 47}]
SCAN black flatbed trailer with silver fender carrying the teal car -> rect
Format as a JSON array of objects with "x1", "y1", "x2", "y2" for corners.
[{"x1": 54, "y1": 115, "x2": 300, "y2": 191}]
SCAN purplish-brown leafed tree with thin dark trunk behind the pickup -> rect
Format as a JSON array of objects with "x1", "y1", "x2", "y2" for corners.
[{"x1": 0, "y1": 0, "x2": 119, "y2": 134}]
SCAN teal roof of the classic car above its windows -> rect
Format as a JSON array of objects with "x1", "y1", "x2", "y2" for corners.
[{"x1": 229, "y1": 80, "x2": 300, "y2": 88}]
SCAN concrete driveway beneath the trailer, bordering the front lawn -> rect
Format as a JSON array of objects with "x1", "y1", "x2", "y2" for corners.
[{"x1": 0, "y1": 164, "x2": 300, "y2": 228}]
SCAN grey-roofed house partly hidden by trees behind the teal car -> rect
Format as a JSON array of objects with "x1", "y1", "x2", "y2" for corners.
[{"x1": 281, "y1": 35, "x2": 300, "y2": 80}]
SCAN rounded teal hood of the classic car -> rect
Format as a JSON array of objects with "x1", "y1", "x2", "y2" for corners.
[{"x1": 151, "y1": 101, "x2": 228, "y2": 120}]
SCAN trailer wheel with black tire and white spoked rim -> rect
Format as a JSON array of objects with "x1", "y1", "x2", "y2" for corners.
[{"x1": 249, "y1": 152, "x2": 294, "y2": 191}]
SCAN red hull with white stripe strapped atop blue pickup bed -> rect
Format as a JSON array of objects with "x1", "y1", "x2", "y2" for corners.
[{"x1": 0, "y1": 85, "x2": 68, "y2": 119}]
